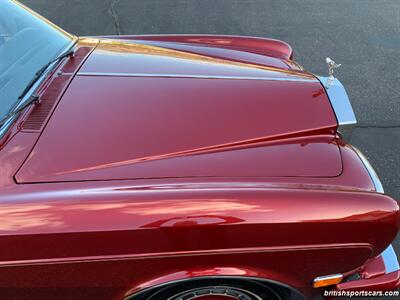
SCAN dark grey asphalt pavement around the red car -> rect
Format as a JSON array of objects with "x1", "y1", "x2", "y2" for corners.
[{"x1": 21, "y1": 0, "x2": 400, "y2": 290}]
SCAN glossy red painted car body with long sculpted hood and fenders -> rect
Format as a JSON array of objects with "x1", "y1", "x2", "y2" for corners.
[{"x1": 0, "y1": 2, "x2": 400, "y2": 299}]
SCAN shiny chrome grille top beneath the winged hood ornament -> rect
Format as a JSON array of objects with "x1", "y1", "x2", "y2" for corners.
[{"x1": 317, "y1": 76, "x2": 357, "y2": 139}]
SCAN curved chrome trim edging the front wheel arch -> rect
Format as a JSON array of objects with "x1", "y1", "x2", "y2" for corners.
[{"x1": 124, "y1": 275, "x2": 306, "y2": 300}]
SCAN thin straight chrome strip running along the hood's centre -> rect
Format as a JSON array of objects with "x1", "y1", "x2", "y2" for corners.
[{"x1": 77, "y1": 72, "x2": 317, "y2": 82}]
